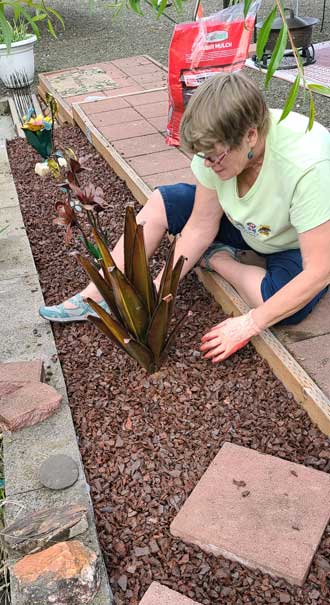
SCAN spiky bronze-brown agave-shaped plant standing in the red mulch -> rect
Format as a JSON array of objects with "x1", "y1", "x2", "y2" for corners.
[{"x1": 77, "y1": 206, "x2": 186, "y2": 373}]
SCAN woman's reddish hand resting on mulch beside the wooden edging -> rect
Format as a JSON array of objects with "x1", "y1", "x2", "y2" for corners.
[{"x1": 200, "y1": 309, "x2": 261, "y2": 363}]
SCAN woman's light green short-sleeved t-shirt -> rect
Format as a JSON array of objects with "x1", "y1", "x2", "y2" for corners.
[{"x1": 191, "y1": 109, "x2": 330, "y2": 254}]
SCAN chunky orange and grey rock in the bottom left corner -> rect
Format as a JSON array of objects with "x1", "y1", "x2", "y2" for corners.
[{"x1": 11, "y1": 540, "x2": 100, "y2": 605}]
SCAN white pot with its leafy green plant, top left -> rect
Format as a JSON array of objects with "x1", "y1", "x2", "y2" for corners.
[{"x1": 0, "y1": 0, "x2": 64, "y2": 88}]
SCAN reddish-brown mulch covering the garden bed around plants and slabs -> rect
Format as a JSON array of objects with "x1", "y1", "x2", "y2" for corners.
[{"x1": 8, "y1": 127, "x2": 330, "y2": 605}]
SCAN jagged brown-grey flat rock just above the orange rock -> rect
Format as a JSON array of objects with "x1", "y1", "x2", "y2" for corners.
[{"x1": 1, "y1": 504, "x2": 88, "y2": 554}]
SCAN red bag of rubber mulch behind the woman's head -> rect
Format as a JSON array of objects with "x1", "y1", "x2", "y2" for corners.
[{"x1": 166, "y1": 1, "x2": 260, "y2": 145}]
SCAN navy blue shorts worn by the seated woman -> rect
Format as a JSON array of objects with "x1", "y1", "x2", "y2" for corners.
[{"x1": 158, "y1": 183, "x2": 328, "y2": 325}]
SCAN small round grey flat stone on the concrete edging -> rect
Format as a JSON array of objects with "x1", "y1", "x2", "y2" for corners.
[{"x1": 39, "y1": 454, "x2": 79, "y2": 489}]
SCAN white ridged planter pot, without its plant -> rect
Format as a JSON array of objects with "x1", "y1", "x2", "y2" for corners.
[{"x1": 0, "y1": 35, "x2": 37, "y2": 88}]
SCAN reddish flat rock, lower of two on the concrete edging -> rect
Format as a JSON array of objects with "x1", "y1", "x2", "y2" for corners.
[{"x1": 0, "y1": 382, "x2": 62, "y2": 431}]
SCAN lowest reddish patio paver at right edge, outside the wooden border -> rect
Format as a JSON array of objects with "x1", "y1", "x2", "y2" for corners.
[{"x1": 286, "y1": 332, "x2": 330, "y2": 398}]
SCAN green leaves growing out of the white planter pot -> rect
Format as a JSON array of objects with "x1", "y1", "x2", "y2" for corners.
[{"x1": 0, "y1": 0, "x2": 64, "y2": 52}]
